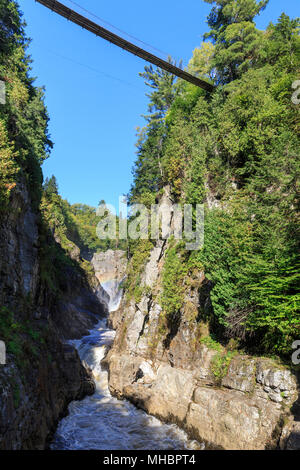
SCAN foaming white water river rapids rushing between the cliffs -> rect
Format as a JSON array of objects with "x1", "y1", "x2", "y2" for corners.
[{"x1": 50, "y1": 280, "x2": 201, "y2": 450}]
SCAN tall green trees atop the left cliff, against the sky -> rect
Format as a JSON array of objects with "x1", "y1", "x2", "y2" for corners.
[{"x1": 0, "y1": 0, "x2": 52, "y2": 215}]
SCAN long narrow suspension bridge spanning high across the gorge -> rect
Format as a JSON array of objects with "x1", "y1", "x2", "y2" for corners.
[{"x1": 36, "y1": 0, "x2": 215, "y2": 92}]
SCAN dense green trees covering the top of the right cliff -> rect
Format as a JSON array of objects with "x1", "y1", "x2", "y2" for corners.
[{"x1": 131, "y1": 4, "x2": 300, "y2": 356}]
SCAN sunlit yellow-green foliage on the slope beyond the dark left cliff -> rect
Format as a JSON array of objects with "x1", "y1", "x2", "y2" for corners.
[{"x1": 40, "y1": 182, "x2": 126, "y2": 280}]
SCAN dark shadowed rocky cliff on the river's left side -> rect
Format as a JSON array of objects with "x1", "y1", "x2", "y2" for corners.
[{"x1": 0, "y1": 183, "x2": 105, "y2": 449}]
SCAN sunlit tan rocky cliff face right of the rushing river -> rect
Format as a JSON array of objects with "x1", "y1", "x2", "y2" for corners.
[{"x1": 104, "y1": 214, "x2": 300, "y2": 449}]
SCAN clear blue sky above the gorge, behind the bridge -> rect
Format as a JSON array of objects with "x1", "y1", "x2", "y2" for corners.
[{"x1": 19, "y1": 0, "x2": 299, "y2": 206}]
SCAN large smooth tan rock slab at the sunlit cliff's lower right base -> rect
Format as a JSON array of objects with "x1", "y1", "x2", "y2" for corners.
[{"x1": 186, "y1": 387, "x2": 280, "y2": 450}]
